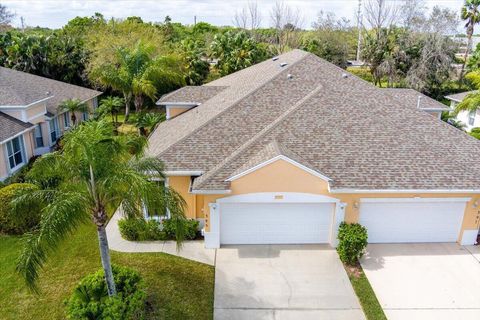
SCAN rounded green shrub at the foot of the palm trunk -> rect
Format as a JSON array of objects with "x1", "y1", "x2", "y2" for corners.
[{"x1": 66, "y1": 265, "x2": 147, "y2": 320}]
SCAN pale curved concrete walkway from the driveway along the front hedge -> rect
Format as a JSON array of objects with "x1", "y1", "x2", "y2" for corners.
[{"x1": 107, "y1": 211, "x2": 215, "y2": 266}]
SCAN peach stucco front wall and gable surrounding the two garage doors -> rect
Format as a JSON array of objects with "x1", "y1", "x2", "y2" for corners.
[{"x1": 170, "y1": 160, "x2": 480, "y2": 241}]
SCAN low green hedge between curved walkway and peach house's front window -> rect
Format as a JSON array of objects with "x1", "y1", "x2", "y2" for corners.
[{"x1": 118, "y1": 218, "x2": 167, "y2": 241}]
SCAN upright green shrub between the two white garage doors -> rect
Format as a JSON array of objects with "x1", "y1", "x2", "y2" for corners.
[{"x1": 337, "y1": 222, "x2": 368, "y2": 265}]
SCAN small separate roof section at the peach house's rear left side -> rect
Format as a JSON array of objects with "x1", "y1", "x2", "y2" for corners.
[{"x1": 157, "y1": 86, "x2": 226, "y2": 105}]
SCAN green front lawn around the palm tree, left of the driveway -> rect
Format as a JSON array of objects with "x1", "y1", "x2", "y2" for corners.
[{"x1": 0, "y1": 226, "x2": 214, "y2": 320}]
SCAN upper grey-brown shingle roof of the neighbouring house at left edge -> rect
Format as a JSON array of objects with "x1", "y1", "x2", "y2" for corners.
[{"x1": 0, "y1": 67, "x2": 102, "y2": 114}]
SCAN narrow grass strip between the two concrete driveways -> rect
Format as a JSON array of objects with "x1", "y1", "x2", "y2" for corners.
[{"x1": 345, "y1": 264, "x2": 387, "y2": 320}]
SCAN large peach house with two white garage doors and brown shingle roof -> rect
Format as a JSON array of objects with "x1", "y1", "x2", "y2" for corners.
[{"x1": 147, "y1": 50, "x2": 480, "y2": 248}]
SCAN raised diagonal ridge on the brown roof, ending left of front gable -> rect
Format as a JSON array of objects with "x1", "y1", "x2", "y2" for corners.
[{"x1": 193, "y1": 84, "x2": 324, "y2": 190}]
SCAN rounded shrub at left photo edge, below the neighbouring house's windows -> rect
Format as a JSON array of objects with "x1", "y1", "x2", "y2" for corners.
[{"x1": 0, "y1": 183, "x2": 40, "y2": 234}]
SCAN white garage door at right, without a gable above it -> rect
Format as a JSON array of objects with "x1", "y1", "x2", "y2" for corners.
[{"x1": 359, "y1": 199, "x2": 466, "y2": 243}]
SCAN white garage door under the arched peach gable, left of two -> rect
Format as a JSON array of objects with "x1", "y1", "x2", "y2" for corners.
[{"x1": 220, "y1": 203, "x2": 334, "y2": 244}]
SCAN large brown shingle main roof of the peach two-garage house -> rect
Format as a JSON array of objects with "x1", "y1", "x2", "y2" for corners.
[{"x1": 147, "y1": 50, "x2": 480, "y2": 192}]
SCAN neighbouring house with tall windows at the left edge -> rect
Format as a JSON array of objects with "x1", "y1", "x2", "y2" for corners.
[{"x1": 0, "y1": 67, "x2": 101, "y2": 181}]
